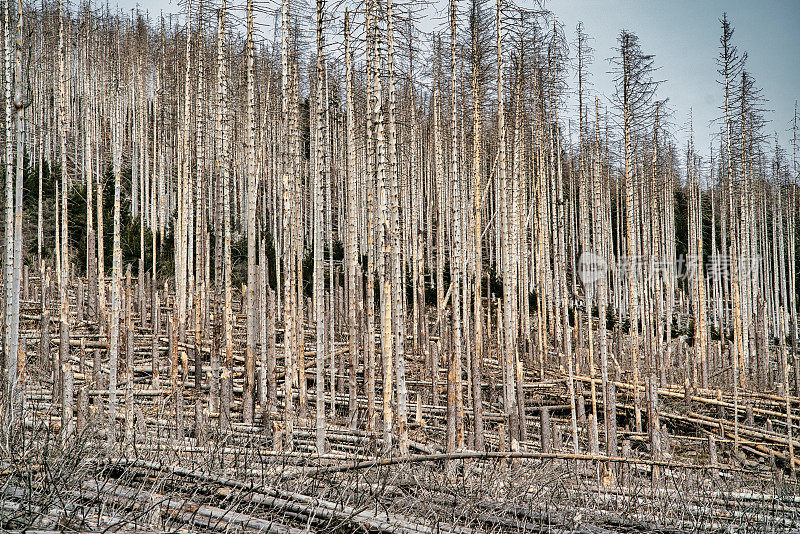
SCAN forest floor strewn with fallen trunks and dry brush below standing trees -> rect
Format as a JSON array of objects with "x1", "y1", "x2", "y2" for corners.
[{"x1": 0, "y1": 282, "x2": 800, "y2": 534}]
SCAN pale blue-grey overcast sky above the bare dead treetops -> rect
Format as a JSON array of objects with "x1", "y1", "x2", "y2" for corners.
[{"x1": 111, "y1": 0, "x2": 800, "y2": 173}]
